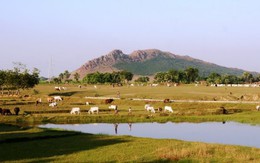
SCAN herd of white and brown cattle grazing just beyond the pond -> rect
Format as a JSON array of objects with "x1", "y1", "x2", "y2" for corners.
[{"x1": 0, "y1": 96, "x2": 260, "y2": 115}]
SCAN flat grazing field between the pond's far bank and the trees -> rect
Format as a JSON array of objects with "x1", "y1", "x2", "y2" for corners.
[{"x1": 0, "y1": 84, "x2": 260, "y2": 124}]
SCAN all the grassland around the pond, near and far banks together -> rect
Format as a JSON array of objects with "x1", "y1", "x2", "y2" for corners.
[{"x1": 0, "y1": 84, "x2": 260, "y2": 162}]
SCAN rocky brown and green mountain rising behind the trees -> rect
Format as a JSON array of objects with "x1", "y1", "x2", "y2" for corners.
[{"x1": 72, "y1": 49, "x2": 256, "y2": 78}]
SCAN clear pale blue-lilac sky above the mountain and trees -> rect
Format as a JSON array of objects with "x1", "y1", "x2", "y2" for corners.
[{"x1": 0, "y1": 0, "x2": 260, "y2": 77}]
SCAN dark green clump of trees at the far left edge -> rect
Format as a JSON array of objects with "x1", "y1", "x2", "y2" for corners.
[{"x1": 0, "y1": 67, "x2": 39, "y2": 95}]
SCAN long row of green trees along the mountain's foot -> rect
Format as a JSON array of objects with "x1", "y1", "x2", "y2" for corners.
[{"x1": 79, "y1": 67, "x2": 260, "y2": 84}]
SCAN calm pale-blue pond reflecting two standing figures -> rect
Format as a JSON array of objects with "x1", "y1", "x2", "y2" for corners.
[{"x1": 39, "y1": 122, "x2": 260, "y2": 148}]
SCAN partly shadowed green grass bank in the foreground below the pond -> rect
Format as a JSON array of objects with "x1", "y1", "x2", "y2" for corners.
[{"x1": 0, "y1": 125, "x2": 260, "y2": 162}]
